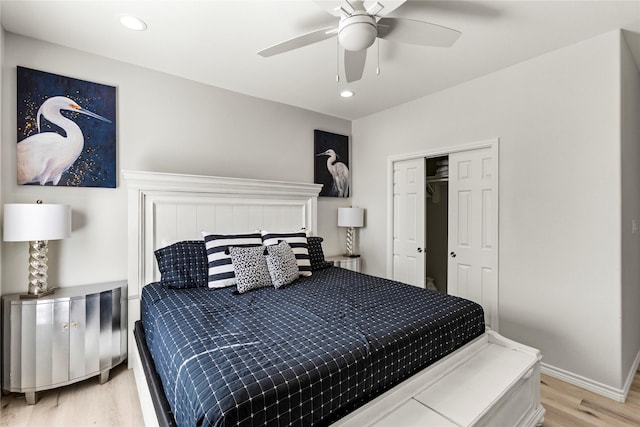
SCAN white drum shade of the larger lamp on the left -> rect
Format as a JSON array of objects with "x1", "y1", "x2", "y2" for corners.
[{"x1": 3, "y1": 203, "x2": 71, "y2": 242}]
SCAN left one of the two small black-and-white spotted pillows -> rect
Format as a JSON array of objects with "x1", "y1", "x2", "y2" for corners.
[{"x1": 229, "y1": 246, "x2": 272, "y2": 294}]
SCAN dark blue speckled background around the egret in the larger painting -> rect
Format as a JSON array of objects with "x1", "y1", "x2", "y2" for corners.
[{"x1": 17, "y1": 67, "x2": 117, "y2": 188}]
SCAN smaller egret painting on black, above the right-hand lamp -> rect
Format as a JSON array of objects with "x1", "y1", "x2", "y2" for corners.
[{"x1": 313, "y1": 129, "x2": 351, "y2": 197}]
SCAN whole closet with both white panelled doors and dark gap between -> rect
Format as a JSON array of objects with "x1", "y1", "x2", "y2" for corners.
[{"x1": 387, "y1": 140, "x2": 499, "y2": 330}]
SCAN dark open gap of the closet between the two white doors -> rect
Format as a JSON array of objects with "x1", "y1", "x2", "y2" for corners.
[{"x1": 425, "y1": 155, "x2": 449, "y2": 293}]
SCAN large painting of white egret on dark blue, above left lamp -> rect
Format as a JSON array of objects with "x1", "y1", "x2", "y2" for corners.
[{"x1": 17, "y1": 67, "x2": 117, "y2": 188}]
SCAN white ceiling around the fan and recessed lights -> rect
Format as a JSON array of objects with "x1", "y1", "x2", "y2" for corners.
[{"x1": 1, "y1": 0, "x2": 640, "y2": 119}]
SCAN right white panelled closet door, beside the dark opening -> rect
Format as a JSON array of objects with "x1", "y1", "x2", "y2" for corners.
[{"x1": 447, "y1": 148, "x2": 498, "y2": 329}]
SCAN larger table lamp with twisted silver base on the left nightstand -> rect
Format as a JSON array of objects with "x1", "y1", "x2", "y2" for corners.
[{"x1": 3, "y1": 200, "x2": 71, "y2": 298}]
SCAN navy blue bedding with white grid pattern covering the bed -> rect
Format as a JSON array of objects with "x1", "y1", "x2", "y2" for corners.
[{"x1": 141, "y1": 267, "x2": 484, "y2": 426}]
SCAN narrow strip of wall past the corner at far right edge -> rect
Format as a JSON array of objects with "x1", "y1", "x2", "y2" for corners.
[{"x1": 620, "y1": 32, "x2": 640, "y2": 388}]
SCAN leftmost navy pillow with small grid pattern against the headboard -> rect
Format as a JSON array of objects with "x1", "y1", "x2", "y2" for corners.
[{"x1": 154, "y1": 240, "x2": 209, "y2": 288}]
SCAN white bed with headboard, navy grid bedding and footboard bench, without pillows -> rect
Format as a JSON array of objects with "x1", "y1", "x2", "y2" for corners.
[{"x1": 124, "y1": 172, "x2": 544, "y2": 425}]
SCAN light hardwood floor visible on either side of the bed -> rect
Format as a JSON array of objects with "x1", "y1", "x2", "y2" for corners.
[{"x1": 0, "y1": 364, "x2": 640, "y2": 427}]
